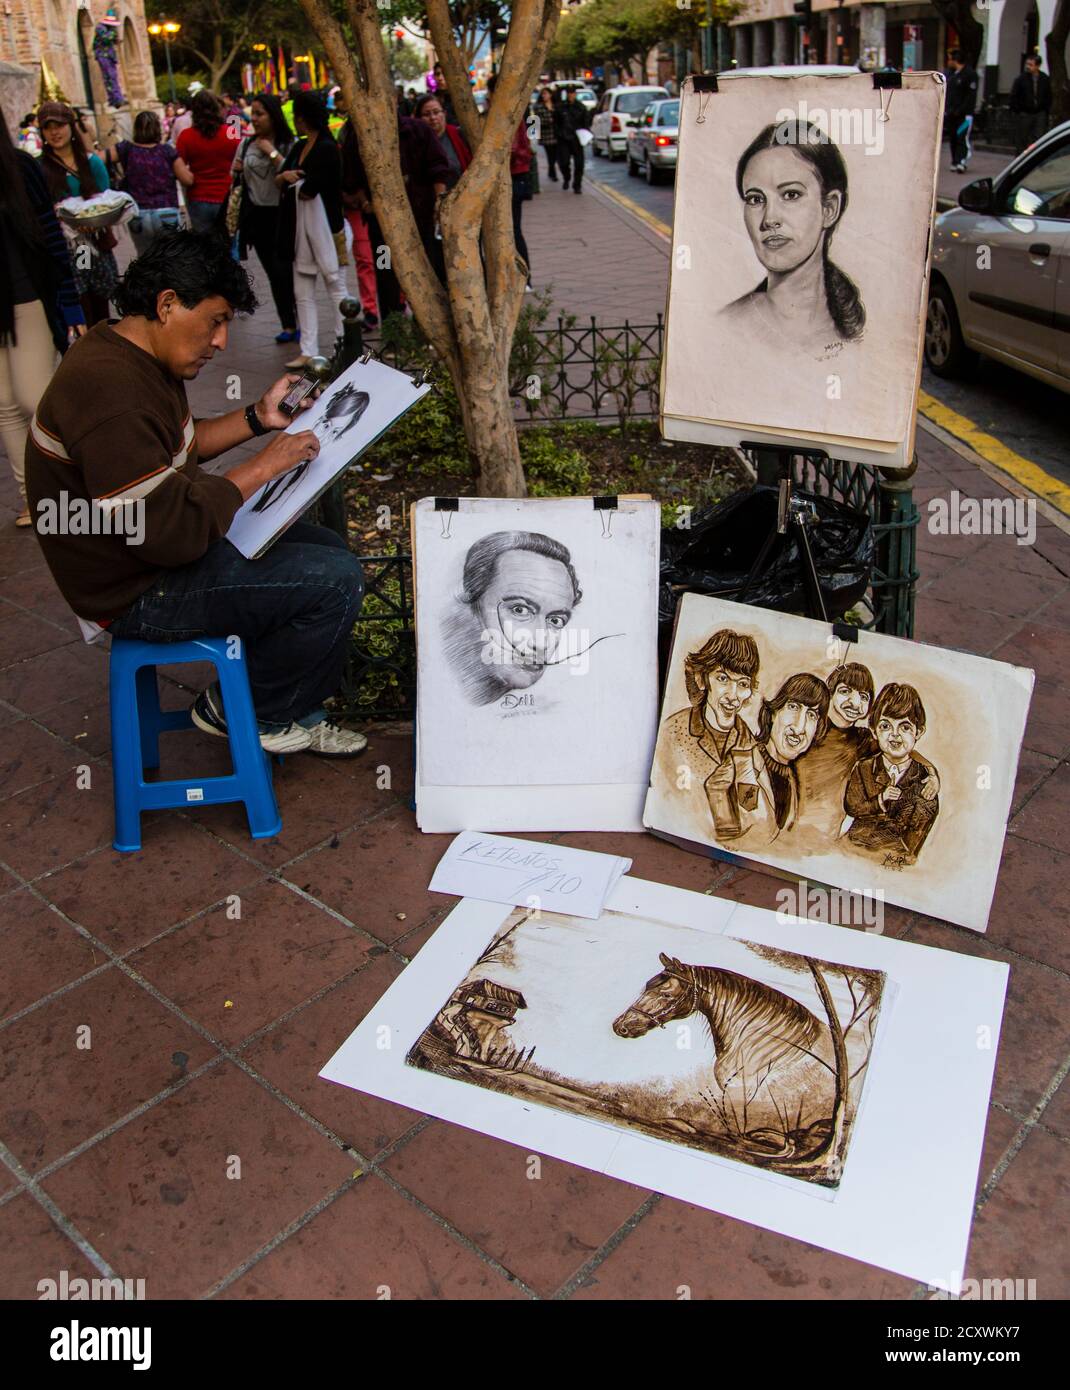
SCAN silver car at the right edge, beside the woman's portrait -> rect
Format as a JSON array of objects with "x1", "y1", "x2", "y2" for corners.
[{"x1": 925, "y1": 121, "x2": 1070, "y2": 392}]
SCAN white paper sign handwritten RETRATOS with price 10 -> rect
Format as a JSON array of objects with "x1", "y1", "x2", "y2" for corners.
[{"x1": 431, "y1": 830, "x2": 632, "y2": 917}]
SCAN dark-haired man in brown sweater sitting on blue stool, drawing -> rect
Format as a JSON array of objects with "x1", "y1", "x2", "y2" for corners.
[{"x1": 26, "y1": 232, "x2": 367, "y2": 758}]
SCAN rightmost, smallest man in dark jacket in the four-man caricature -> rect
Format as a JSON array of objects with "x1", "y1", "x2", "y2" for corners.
[{"x1": 843, "y1": 684, "x2": 939, "y2": 866}]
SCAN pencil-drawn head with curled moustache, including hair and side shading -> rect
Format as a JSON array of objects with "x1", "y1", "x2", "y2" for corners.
[{"x1": 443, "y1": 531, "x2": 583, "y2": 705}]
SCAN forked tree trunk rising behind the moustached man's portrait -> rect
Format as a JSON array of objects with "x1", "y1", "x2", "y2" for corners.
[{"x1": 295, "y1": 0, "x2": 560, "y2": 496}]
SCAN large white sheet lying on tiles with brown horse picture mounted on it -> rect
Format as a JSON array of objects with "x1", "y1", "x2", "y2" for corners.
[{"x1": 321, "y1": 877, "x2": 1007, "y2": 1293}]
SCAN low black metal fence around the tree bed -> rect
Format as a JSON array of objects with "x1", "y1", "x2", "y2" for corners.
[{"x1": 336, "y1": 316, "x2": 919, "y2": 720}]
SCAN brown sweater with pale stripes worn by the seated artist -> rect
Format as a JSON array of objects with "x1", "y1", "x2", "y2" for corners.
[{"x1": 26, "y1": 324, "x2": 242, "y2": 623}]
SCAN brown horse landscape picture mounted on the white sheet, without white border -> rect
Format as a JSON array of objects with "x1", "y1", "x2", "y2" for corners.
[{"x1": 407, "y1": 909, "x2": 885, "y2": 1187}]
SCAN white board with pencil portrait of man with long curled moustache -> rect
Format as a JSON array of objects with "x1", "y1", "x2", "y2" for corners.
[{"x1": 413, "y1": 498, "x2": 660, "y2": 831}]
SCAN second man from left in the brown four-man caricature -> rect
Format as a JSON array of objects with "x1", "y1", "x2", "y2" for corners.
[{"x1": 706, "y1": 671, "x2": 828, "y2": 852}]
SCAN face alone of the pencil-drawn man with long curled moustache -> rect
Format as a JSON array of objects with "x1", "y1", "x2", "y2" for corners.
[{"x1": 475, "y1": 550, "x2": 575, "y2": 689}]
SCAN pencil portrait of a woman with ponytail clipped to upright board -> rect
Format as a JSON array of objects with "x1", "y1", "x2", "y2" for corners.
[{"x1": 661, "y1": 70, "x2": 944, "y2": 467}]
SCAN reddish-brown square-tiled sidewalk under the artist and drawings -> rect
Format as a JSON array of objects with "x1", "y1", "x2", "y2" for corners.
[{"x1": 0, "y1": 193, "x2": 1070, "y2": 1300}]
